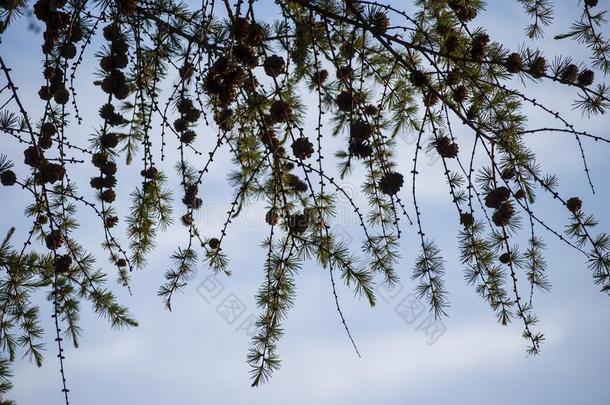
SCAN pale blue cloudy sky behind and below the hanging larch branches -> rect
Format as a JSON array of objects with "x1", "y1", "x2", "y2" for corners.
[{"x1": 0, "y1": 0, "x2": 610, "y2": 405}]
